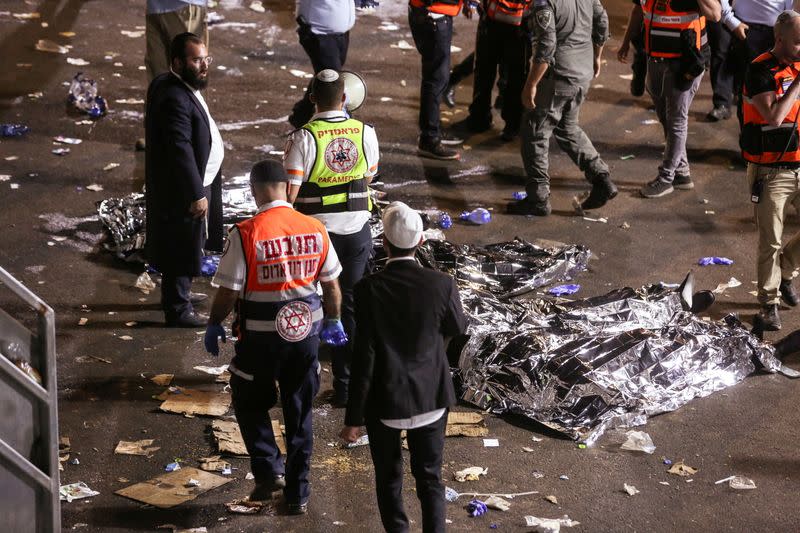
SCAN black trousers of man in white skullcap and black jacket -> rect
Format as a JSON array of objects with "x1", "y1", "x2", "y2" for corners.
[{"x1": 367, "y1": 412, "x2": 447, "y2": 533}]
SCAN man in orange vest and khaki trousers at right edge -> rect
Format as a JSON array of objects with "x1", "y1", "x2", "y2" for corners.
[{"x1": 740, "y1": 11, "x2": 800, "y2": 331}]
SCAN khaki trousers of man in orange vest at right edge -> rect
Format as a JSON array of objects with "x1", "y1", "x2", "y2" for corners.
[{"x1": 747, "y1": 163, "x2": 800, "y2": 305}]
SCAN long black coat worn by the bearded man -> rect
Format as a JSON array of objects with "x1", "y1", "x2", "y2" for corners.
[{"x1": 145, "y1": 72, "x2": 223, "y2": 276}]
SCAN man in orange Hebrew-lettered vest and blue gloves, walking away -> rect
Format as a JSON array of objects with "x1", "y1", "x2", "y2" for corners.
[{"x1": 205, "y1": 161, "x2": 342, "y2": 514}]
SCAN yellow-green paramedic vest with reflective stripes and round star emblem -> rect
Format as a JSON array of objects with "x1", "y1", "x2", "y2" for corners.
[{"x1": 295, "y1": 118, "x2": 372, "y2": 215}]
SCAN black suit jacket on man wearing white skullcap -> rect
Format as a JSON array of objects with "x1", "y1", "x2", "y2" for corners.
[{"x1": 345, "y1": 260, "x2": 467, "y2": 426}]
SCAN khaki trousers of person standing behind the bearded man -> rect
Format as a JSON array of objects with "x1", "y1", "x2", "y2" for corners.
[{"x1": 144, "y1": 4, "x2": 208, "y2": 85}]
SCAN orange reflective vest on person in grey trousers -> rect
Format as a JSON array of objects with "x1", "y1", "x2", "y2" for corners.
[{"x1": 642, "y1": 0, "x2": 708, "y2": 59}]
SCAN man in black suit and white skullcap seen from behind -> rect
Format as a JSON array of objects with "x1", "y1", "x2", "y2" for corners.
[{"x1": 340, "y1": 202, "x2": 466, "y2": 533}]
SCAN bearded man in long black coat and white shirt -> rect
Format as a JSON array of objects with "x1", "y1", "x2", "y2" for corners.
[{"x1": 145, "y1": 33, "x2": 225, "y2": 327}]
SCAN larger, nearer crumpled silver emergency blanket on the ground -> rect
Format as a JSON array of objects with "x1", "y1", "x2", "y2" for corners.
[{"x1": 456, "y1": 287, "x2": 781, "y2": 444}]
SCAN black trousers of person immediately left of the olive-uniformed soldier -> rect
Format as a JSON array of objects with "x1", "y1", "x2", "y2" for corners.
[{"x1": 469, "y1": 17, "x2": 531, "y2": 133}]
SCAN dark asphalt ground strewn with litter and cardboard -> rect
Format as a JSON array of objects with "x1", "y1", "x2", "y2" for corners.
[{"x1": 0, "y1": 0, "x2": 800, "y2": 532}]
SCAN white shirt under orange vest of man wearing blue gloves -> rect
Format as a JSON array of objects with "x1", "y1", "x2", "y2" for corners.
[{"x1": 211, "y1": 200, "x2": 342, "y2": 300}]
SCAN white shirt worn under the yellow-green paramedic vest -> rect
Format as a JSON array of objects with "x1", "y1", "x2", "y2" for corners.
[{"x1": 283, "y1": 111, "x2": 379, "y2": 235}]
